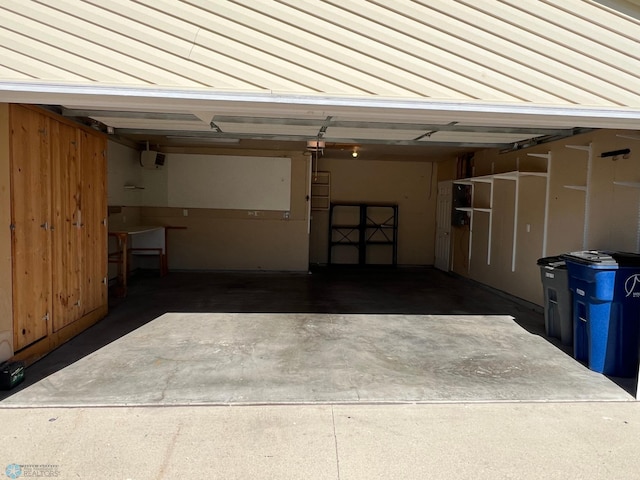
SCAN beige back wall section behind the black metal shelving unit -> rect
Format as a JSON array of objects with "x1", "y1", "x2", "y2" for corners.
[{"x1": 310, "y1": 158, "x2": 437, "y2": 265}]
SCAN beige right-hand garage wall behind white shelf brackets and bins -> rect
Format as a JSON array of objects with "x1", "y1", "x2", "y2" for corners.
[{"x1": 440, "y1": 130, "x2": 640, "y2": 305}]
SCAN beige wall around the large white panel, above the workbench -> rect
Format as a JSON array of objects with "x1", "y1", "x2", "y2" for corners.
[{"x1": 109, "y1": 145, "x2": 309, "y2": 277}]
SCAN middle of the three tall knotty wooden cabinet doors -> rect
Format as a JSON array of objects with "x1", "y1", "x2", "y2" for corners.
[{"x1": 51, "y1": 122, "x2": 82, "y2": 332}]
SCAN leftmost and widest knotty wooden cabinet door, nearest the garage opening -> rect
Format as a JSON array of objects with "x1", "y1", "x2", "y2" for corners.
[{"x1": 10, "y1": 105, "x2": 51, "y2": 351}]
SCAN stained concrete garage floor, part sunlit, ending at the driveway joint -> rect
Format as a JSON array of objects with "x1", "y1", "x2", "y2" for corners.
[{"x1": 0, "y1": 269, "x2": 635, "y2": 407}]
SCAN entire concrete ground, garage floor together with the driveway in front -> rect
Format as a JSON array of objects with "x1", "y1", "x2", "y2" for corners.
[{"x1": 0, "y1": 269, "x2": 640, "y2": 480}]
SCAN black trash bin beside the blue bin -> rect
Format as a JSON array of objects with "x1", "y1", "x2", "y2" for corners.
[{"x1": 538, "y1": 257, "x2": 573, "y2": 345}]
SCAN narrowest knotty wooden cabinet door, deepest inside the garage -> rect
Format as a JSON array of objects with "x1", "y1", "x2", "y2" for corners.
[{"x1": 80, "y1": 131, "x2": 107, "y2": 314}]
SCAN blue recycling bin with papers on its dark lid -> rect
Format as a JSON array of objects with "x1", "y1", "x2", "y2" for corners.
[{"x1": 562, "y1": 250, "x2": 640, "y2": 377}]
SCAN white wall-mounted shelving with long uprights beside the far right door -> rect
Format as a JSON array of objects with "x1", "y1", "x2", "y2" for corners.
[{"x1": 453, "y1": 165, "x2": 551, "y2": 272}]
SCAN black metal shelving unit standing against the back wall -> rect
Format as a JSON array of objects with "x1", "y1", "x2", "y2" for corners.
[{"x1": 327, "y1": 202, "x2": 398, "y2": 267}]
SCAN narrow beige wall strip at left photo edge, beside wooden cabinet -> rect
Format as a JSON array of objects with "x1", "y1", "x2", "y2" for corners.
[{"x1": 0, "y1": 104, "x2": 13, "y2": 362}]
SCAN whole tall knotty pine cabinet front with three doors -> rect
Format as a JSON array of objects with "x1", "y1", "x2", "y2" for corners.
[{"x1": 10, "y1": 105, "x2": 107, "y2": 351}]
